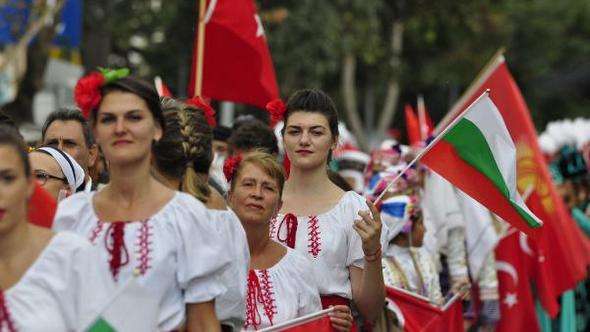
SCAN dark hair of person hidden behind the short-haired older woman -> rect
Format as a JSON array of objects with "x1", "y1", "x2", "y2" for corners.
[{"x1": 228, "y1": 120, "x2": 279, "y2": 155}]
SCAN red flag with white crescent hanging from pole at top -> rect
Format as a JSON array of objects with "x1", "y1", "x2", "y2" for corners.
[{"x1": 189, "y1": 0, "x2": 279, "y2": 108}]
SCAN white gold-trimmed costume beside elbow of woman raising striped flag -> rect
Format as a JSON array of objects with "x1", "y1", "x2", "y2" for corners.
[{"x1": 383, "y1": 244, "x2": 444, "y2": 305}]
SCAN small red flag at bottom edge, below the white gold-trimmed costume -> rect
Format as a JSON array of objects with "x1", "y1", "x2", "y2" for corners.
[{"x1": 385, "y1": 287, "x2": 464, "y2": 332}]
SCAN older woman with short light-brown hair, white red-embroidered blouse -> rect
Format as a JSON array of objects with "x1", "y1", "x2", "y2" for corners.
[{"x1": 225, "y1": 152, "x2": 352, "y2": 331}]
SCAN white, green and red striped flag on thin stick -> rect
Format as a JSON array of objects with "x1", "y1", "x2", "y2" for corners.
[{"x1": 421, "y1": 92, "x2": 542, "y2": 236}]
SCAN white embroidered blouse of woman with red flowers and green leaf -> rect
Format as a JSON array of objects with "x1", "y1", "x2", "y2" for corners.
[{"x1": 53, "y1": 192, "x2": 230, "y2": 331}]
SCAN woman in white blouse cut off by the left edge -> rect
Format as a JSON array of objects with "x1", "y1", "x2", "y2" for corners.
[{"x1": 0, "y1": 126, "x2": 110, "y2": 332}]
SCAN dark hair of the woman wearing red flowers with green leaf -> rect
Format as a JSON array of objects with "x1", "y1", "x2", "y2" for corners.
[{"x1": 90, "y1": 76, "x2": 166, "y2": 130}]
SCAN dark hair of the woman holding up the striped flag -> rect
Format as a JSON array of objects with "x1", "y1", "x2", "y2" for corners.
[{"x1": 282, "y1": 89, "x2": 339, "y2": 139}]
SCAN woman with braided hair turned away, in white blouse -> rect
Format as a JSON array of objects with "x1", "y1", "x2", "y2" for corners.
[{"x1": 154, "y1": 98, "x2": 250, "y2": 330}]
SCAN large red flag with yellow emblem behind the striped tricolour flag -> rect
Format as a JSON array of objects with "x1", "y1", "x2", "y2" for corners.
[{"x1": 439, "y1": 55, "x2": 590, "y2": 317}]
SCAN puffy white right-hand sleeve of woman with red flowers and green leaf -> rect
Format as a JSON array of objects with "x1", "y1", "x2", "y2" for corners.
[{"x1": 175, "y1": 194, "x2": 230, "y2": 303}]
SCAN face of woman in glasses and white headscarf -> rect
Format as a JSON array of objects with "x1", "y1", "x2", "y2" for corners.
[{"x1": 29, "y1": 151, "x2": 69, "y2": 200}]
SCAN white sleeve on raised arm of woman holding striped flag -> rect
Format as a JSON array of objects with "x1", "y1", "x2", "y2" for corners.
[{"x1": 341, "y1": 193, "x2": 369, "y2": 269}]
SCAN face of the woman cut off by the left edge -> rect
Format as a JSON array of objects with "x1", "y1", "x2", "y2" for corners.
[{"x1": 0, "y1": 145, "x2": 35, "y2": 234}]
